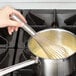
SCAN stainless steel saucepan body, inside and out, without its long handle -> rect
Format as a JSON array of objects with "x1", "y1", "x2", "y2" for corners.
[{"x1": 28, "y1": 28, "x2": 76, "y2": 76}]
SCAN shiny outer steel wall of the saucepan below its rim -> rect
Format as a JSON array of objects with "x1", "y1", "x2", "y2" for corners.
[{"x1": 39, "y1": 54, "x2": 76, "y2": 76}]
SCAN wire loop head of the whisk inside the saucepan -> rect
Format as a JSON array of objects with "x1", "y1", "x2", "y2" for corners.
[{"x1": 34, "y1": 35, "x2": 69, "y2": 59}]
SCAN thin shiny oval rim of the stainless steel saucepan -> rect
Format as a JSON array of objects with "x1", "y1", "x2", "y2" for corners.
[{"x1": 28, "y1": 28, "x2": 76, "y2": 60}]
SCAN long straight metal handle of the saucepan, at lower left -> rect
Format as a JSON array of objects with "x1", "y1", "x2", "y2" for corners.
[{"x1": 0, "y1": 57, "x2": 38, "y2": 76}]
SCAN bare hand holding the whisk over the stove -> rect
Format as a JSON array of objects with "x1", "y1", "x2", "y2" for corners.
[{"x1": 0, "y1": 6, "x2": 26, "y2": 35}]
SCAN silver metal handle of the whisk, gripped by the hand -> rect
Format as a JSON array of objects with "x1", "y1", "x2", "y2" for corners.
[{"x1": 11, "y1": 15, "x2": 36, "y2": 37}]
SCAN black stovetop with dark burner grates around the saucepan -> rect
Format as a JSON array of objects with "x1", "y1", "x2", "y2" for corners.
[{"x1": 0, "y1": 10, "x2": 76, "y2": 76}]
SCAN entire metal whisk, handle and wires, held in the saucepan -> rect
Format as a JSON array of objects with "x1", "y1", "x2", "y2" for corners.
[{"x1": 12, "y1": 15, "x2": 72, "y2": 59}]
